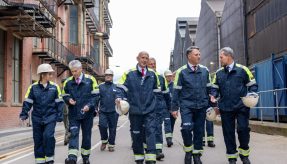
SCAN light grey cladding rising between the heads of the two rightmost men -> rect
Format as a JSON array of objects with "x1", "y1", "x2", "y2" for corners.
[{"x1": 195, "y1": 0, "x2": 218, "y2": 72}]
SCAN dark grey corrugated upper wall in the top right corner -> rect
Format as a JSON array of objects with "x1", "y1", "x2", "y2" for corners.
[{"x1": 247, "y1": 0, "x2": 287, "y2": 65}]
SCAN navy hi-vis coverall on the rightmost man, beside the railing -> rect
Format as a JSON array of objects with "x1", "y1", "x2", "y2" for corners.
[{"x1": 212, "y1": 63, "x2": 258, "y2": 159}]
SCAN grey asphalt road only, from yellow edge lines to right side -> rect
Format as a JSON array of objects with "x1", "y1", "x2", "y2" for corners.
[{"x1": 0, "y1": 116, "x2": 287, "y2": 164}]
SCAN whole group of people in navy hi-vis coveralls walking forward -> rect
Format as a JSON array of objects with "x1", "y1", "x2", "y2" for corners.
[{"x1": 20, "y1": 46, "x2": 257, "y2": 164}]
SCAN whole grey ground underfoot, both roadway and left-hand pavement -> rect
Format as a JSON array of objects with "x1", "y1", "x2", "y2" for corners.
[{"x1": 0, "y1": 116, "x2": 287, "y2": 164}]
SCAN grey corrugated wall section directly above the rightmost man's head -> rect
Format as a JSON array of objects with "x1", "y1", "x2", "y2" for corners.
[{"x1": 221, "y1": 0, "x2": 246, "y2": 65}]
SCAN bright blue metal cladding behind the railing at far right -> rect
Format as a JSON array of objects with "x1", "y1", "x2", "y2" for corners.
[{"x1": 251, "y1": 55, "x2": 287, "y2": 121}]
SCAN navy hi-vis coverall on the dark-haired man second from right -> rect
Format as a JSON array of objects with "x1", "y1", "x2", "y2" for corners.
[{"x1": 172, "y1": 64, "x2": 211, "y2": 154}]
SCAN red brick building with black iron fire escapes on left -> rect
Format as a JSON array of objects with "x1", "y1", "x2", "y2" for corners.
[{"x1": 0, "y1": 0, "x2": 113, "y2": 129}]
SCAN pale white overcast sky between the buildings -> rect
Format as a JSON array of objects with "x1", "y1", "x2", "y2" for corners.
[{"x1": 109, "y1": 0, "x2": 201, "y2": 80}]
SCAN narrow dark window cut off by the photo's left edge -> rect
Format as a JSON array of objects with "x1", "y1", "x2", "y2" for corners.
[{"x1": 0, "y1": 30, "x2": 5, "y2": 101}]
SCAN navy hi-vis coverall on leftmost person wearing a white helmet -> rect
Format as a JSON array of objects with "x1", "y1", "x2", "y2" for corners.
[{"x1": 20, "y1": 81, "x2": 64, "y2": 163}]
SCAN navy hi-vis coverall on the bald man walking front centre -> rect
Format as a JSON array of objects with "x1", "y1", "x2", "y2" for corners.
[{"x1": 118, "y1": 66, "x2": 161, "y2": 161}]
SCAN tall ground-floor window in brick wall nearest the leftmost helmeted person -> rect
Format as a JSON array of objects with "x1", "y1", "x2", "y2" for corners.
[{"x1": 12, "y1": 38, "x2": 21, "y2": 103}]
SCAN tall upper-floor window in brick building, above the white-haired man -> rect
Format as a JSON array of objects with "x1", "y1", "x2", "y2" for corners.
[{"x1": 69, "y1": 5, "x2": 78, "y2": 44}]
